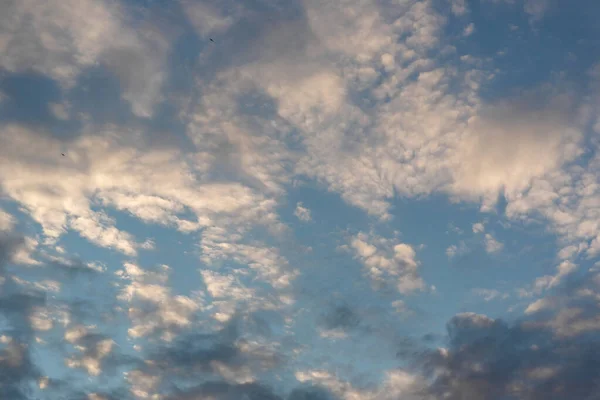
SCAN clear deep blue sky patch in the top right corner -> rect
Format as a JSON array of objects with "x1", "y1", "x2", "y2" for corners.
[{"x1": 454, "y1": 0, "x2": 598, "y2": 101}]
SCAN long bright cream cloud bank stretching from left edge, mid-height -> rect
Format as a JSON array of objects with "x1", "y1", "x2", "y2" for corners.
[{"x1": 0, "y1": 126, "x2": 288, "y2": 255}]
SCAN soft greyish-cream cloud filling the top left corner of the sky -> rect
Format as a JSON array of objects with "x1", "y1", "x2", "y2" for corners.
[{"x1": 0, "y1": 0, "x2": 167, "y2": 117}]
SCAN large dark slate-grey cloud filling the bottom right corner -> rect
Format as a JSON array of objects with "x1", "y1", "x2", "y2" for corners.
[{"x1": 413, "y1": 274, "x2": 600, "y2": 400}]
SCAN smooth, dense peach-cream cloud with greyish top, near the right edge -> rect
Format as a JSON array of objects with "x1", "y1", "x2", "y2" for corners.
[{"x1": 453, "y1": 92, "x2": 582, "y2": 206}]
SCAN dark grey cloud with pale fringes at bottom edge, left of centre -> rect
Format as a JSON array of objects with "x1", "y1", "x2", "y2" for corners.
[{"x1": 136, "y1": 313, "x2": 292, "y2": 399}]
